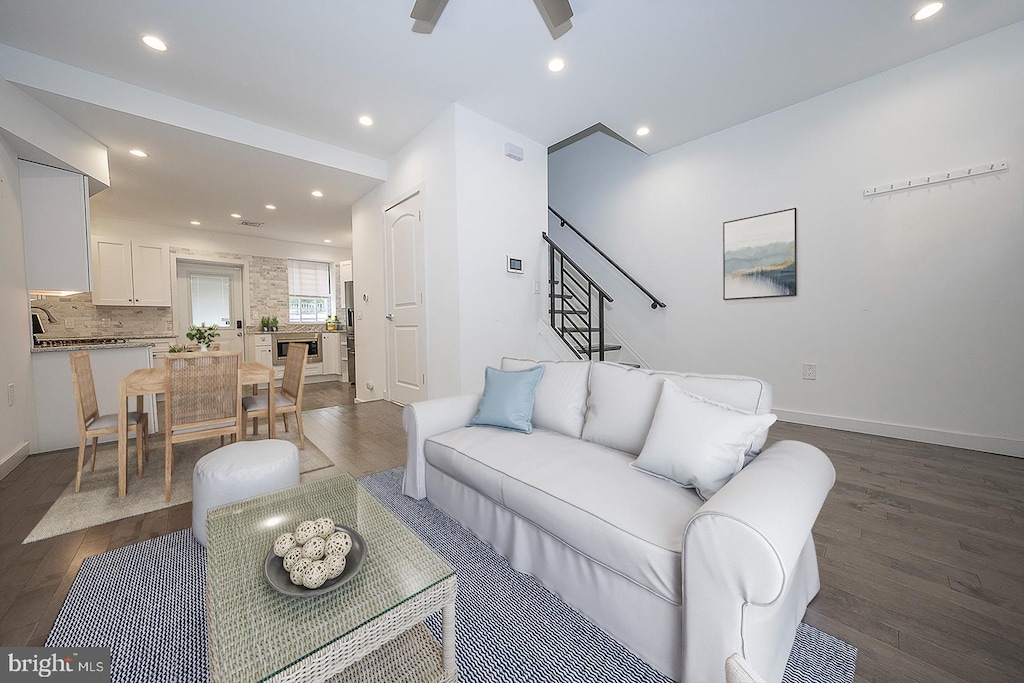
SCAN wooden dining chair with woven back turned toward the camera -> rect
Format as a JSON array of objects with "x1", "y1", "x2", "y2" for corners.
[{"x1": 164, "y1": 351, "x2": 245, "y2": 503}]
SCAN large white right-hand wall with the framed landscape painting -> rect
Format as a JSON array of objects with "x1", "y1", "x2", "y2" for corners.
[{"x1": 549, "y1": 24, "x2": 1024, "y2": 456}]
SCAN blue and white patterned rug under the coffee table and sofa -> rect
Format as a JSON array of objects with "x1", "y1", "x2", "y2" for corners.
[{"x1": 46, "y1": 468, "x2": 857, "y2": 683}]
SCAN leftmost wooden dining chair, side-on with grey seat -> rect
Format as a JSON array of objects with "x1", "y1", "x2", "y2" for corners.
[{"x1": 70, "y1": 351, "x2": 150, "y2": 493}]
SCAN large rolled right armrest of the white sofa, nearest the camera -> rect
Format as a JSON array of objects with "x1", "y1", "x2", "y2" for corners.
[{"x1": 683, "y1": 441, "x2": 836, "y2": 681}]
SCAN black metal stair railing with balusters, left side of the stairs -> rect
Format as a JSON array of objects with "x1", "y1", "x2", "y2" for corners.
[{"x1": 541, "y1": 232, "x2": 613, "y2": 360}]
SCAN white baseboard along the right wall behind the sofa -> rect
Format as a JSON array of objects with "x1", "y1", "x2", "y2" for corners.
[{"x1": 772, "y1": 409, "x2": 1024, "y2": 458}]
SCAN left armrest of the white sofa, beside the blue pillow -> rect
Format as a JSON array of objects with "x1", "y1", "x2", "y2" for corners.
[{"x1": 401, "y1": 393, "x2": 480, "y2": 500}]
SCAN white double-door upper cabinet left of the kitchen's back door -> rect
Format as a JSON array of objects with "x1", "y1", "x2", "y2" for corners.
[{"x1": 92, "y1": 238, "x2": 171, "y2": 306}]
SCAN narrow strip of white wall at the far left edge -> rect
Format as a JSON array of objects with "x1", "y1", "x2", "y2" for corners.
[{"x1": 0, "y1": 133, "x2": 36, "y2": 476}]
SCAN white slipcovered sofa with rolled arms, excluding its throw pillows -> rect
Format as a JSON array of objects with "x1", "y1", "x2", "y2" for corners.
[{"x1": 403, "y1": 358, "x2": 835, "y2": 683}]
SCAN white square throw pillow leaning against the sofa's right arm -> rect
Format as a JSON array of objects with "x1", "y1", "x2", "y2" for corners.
[{"x1": 630, "y1": 380, "x2": 776, "y2": 501}]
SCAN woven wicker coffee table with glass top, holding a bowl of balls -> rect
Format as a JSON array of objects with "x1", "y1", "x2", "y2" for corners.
[{"x1": 206, "y1": 474, "x2": 458, "y2": 683}]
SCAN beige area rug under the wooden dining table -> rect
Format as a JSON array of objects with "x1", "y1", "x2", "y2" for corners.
[{"x1": 23, "y1": 429, "x2": 338, "y2": 543}]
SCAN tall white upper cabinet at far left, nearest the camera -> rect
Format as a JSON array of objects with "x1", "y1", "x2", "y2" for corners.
[{"x1": 18, "y1": 161, "x2": 92, "y2": 294}]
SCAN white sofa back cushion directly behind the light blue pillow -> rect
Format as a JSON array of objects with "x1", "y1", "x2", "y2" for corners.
[{"x1": 502, "y1": 358, "x2": 590, "y2": 438}]
